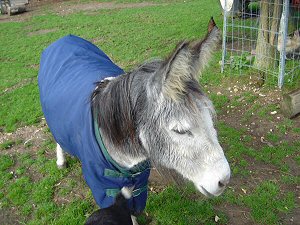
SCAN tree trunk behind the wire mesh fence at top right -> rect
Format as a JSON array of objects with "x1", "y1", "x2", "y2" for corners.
[{"x1": 254, "y1": 0, "x2": 282, "y2": 71}]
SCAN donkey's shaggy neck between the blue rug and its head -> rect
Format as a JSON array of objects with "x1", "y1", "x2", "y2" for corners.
[{"x1": 92, "y1": 68, "x2": 154, "y2": 169}]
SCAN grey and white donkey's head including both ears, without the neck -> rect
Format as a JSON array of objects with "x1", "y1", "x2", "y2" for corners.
[{"x1": 139, "y1": 19, "x2": 230, "y2": 196}]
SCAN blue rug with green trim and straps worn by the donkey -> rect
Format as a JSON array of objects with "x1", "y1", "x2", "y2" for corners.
[{"x1": 38, "y1": 35, "x2": 150, "y2": 213}]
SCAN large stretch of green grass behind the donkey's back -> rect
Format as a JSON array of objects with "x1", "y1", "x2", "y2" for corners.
[{"x1": 0, "y1": 1, "x2": 222, "y2": 131}]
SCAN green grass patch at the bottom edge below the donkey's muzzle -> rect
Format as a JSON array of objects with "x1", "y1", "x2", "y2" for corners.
[{"x1": 146, "y1": 187, "x2": 227, "y2": 224}]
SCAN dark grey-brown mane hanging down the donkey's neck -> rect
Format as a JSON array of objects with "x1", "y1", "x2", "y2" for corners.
[{"x1": 92, "y1": 60, "x2": 161, "y2": 156}]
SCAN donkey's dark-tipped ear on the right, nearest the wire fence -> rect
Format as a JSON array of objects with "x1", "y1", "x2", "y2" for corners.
[{"x1": 190, "y1": 17, "x2": 221, "y2": 77}]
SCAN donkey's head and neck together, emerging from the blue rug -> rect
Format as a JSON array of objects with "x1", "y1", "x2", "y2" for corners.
[{"x1": 93, "y1": 19, "x2": 230, "y2": 196}]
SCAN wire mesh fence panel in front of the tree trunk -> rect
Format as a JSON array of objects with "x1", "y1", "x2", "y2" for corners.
[{"x1": 222, "y1": 0, "x2": 300, "y2": 87}]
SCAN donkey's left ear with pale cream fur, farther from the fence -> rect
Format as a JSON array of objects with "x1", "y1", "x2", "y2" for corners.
[{"x1": 162, "y1": 41, "x2": 192, "y2": 100}]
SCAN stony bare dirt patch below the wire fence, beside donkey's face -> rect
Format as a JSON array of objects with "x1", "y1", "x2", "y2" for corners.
[{"x1": 209, "y1": 79, "x2": 300, "y2": 149}]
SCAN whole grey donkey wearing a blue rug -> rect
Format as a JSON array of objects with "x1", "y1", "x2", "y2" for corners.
[{"x1": 38, "y1": 18, "x2": 230, "y2": 221}]
